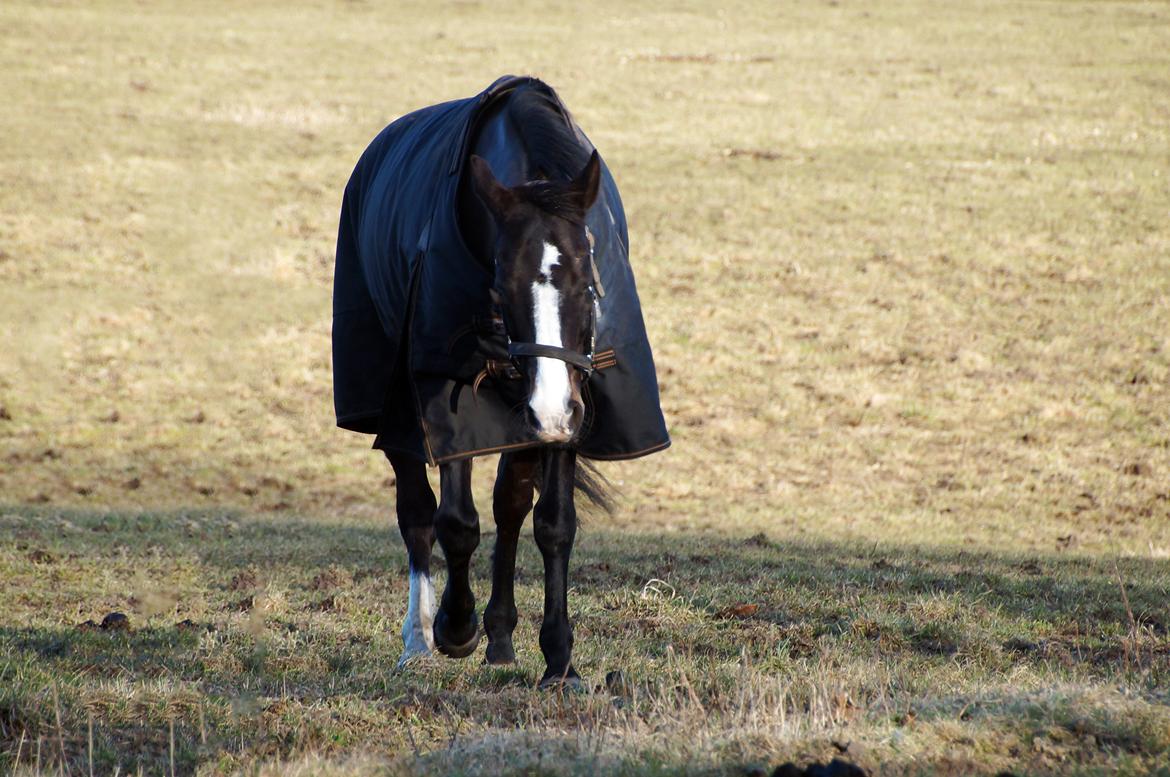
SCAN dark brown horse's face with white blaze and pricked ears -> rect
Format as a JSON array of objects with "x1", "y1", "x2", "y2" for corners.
[{"x1": 472, "y1": 153, "x2": 600, "y2": 442}]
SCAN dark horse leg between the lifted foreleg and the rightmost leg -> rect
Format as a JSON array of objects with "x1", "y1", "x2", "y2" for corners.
[{"x1": 483, "y1": 451, "x2": 541, "y2": 663}]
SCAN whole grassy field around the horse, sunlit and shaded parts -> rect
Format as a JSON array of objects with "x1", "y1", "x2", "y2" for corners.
[{"x1": 0, "y1": 0, "x2": 1170, "y2": 775}]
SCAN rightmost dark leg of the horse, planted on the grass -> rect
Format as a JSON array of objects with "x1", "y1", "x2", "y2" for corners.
[{"x1": 532, "y1": 448, "x2": 580, "y2": 688}]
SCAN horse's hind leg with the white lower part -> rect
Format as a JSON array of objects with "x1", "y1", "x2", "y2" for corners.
[{"x1": 386, "y1": 453, "x2": 435, "y2": 668}]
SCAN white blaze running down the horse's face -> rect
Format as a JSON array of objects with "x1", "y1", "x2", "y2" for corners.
[{"x1": 529, "y1": 243, "x2": 571, "y2": 440}]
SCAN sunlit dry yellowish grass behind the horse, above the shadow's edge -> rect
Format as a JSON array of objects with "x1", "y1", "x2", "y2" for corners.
[{"x1": 0, "y1": 2, "x2": 1170, "y2": 552}]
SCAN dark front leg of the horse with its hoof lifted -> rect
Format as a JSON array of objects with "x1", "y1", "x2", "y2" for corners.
[{"x1": 434, "y1": 459, "x2": 480, "y2": 659}]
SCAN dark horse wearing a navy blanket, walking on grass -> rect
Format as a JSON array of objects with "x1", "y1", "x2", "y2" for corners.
[{"x1": 333, "y1": 76, "x2": 670, "y2": 688}]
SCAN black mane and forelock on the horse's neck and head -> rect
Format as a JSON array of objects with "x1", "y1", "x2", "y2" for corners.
[{"x1": 507, "y1": 88, "x2": 593, "y2": 221}]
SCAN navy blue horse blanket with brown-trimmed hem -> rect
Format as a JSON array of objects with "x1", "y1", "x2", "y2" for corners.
[{"x1": 333, "y1": 76, "x2": 670, "y2": 465}]
